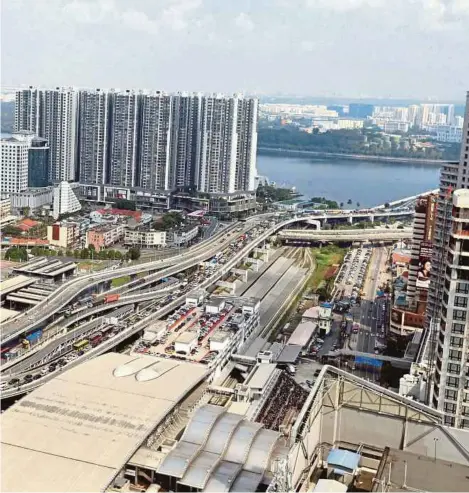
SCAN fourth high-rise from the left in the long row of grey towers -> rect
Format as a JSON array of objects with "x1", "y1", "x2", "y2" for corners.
[{"x1": 109, "y1": 90, "x2": 141, "y2": 187}]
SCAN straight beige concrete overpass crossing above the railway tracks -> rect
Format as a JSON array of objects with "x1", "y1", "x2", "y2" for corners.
[{"x1": 278, "y1": 228, "x2": 412, "y2": 241}]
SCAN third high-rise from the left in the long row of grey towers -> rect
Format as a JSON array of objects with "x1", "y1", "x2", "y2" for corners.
[{"x1": 78, "y1": 89, "x2": 114, "y2": 185}]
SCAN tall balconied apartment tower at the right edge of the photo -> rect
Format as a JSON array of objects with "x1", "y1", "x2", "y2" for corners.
[{"x1": 425, "y1": 92, "x2": 469, "y2": 427}]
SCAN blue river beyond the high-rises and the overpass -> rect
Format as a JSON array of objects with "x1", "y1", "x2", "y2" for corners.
[{"x1": 257, "y1": 153, "x2": 440, "y2": 207}]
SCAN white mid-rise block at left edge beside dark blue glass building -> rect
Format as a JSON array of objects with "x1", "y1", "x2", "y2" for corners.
[{"x1": 0, "y1": 138, "x2": 29, "y2": 193}]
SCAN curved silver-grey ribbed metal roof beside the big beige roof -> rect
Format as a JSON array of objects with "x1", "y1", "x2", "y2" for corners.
[{"x1": 158, "y1": 406, "x2": 283, "y2": 492}]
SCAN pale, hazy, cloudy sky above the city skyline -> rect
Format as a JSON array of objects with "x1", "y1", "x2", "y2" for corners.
[{"x1": 1, "y1": 0, "x2": 469, "y2": 101}]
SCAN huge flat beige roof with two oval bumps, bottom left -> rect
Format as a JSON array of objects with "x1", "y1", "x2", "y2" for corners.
[{"x1": 1, "y1": 353, "x2": 206, "y2": 492}]
